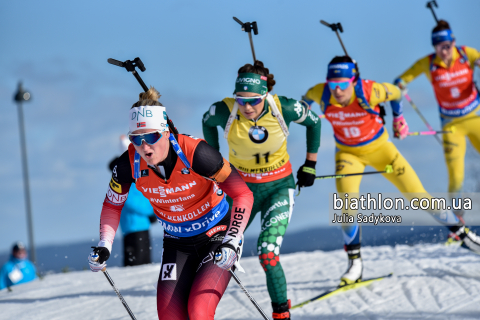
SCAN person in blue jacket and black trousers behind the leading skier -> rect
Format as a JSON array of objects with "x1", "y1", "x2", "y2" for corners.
[{"x1": 109, "y1": 135, "x2": 157, "y2": 266}]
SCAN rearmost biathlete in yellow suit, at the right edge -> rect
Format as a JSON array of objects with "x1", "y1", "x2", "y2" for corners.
[{"x1": 394, "y1": 20, "x2": 480, "y2": 208}]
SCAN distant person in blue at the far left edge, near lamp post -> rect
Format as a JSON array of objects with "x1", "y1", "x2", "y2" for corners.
[{"x1": 0, "y1": 242, "x2": 37, "y2": 290}]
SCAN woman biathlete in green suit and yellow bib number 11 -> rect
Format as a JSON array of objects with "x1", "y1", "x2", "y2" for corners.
[{"x1": 203, "y1": 60, "x2": 320, "y2": 319}]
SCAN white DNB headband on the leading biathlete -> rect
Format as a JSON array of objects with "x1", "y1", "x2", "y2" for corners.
[{"x1": 128, "y1": 106, "x2": 168, "y2": 134}]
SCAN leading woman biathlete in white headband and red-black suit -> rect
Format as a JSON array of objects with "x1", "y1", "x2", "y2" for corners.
[{"x1": 88, "y1": 88, "x2": 253, "y2": 320}]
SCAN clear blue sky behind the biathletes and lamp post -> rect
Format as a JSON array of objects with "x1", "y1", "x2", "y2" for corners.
[{"x1": 0, "y1": 0, "x2": 480, "y2": 255}]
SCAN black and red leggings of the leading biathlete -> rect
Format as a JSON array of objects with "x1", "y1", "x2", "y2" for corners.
[{"x1": 157, "y1": 217, "x2": 231, "y2": 320}]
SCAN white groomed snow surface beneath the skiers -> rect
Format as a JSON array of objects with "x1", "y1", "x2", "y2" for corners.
[{"x1": 0, "y1": 244, "x2": 480, "y2": 320}]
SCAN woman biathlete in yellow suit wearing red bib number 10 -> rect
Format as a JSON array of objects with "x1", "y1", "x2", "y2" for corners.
[{"x1": 304, "y1": 56, "x2": 480, "y2": 285}]
